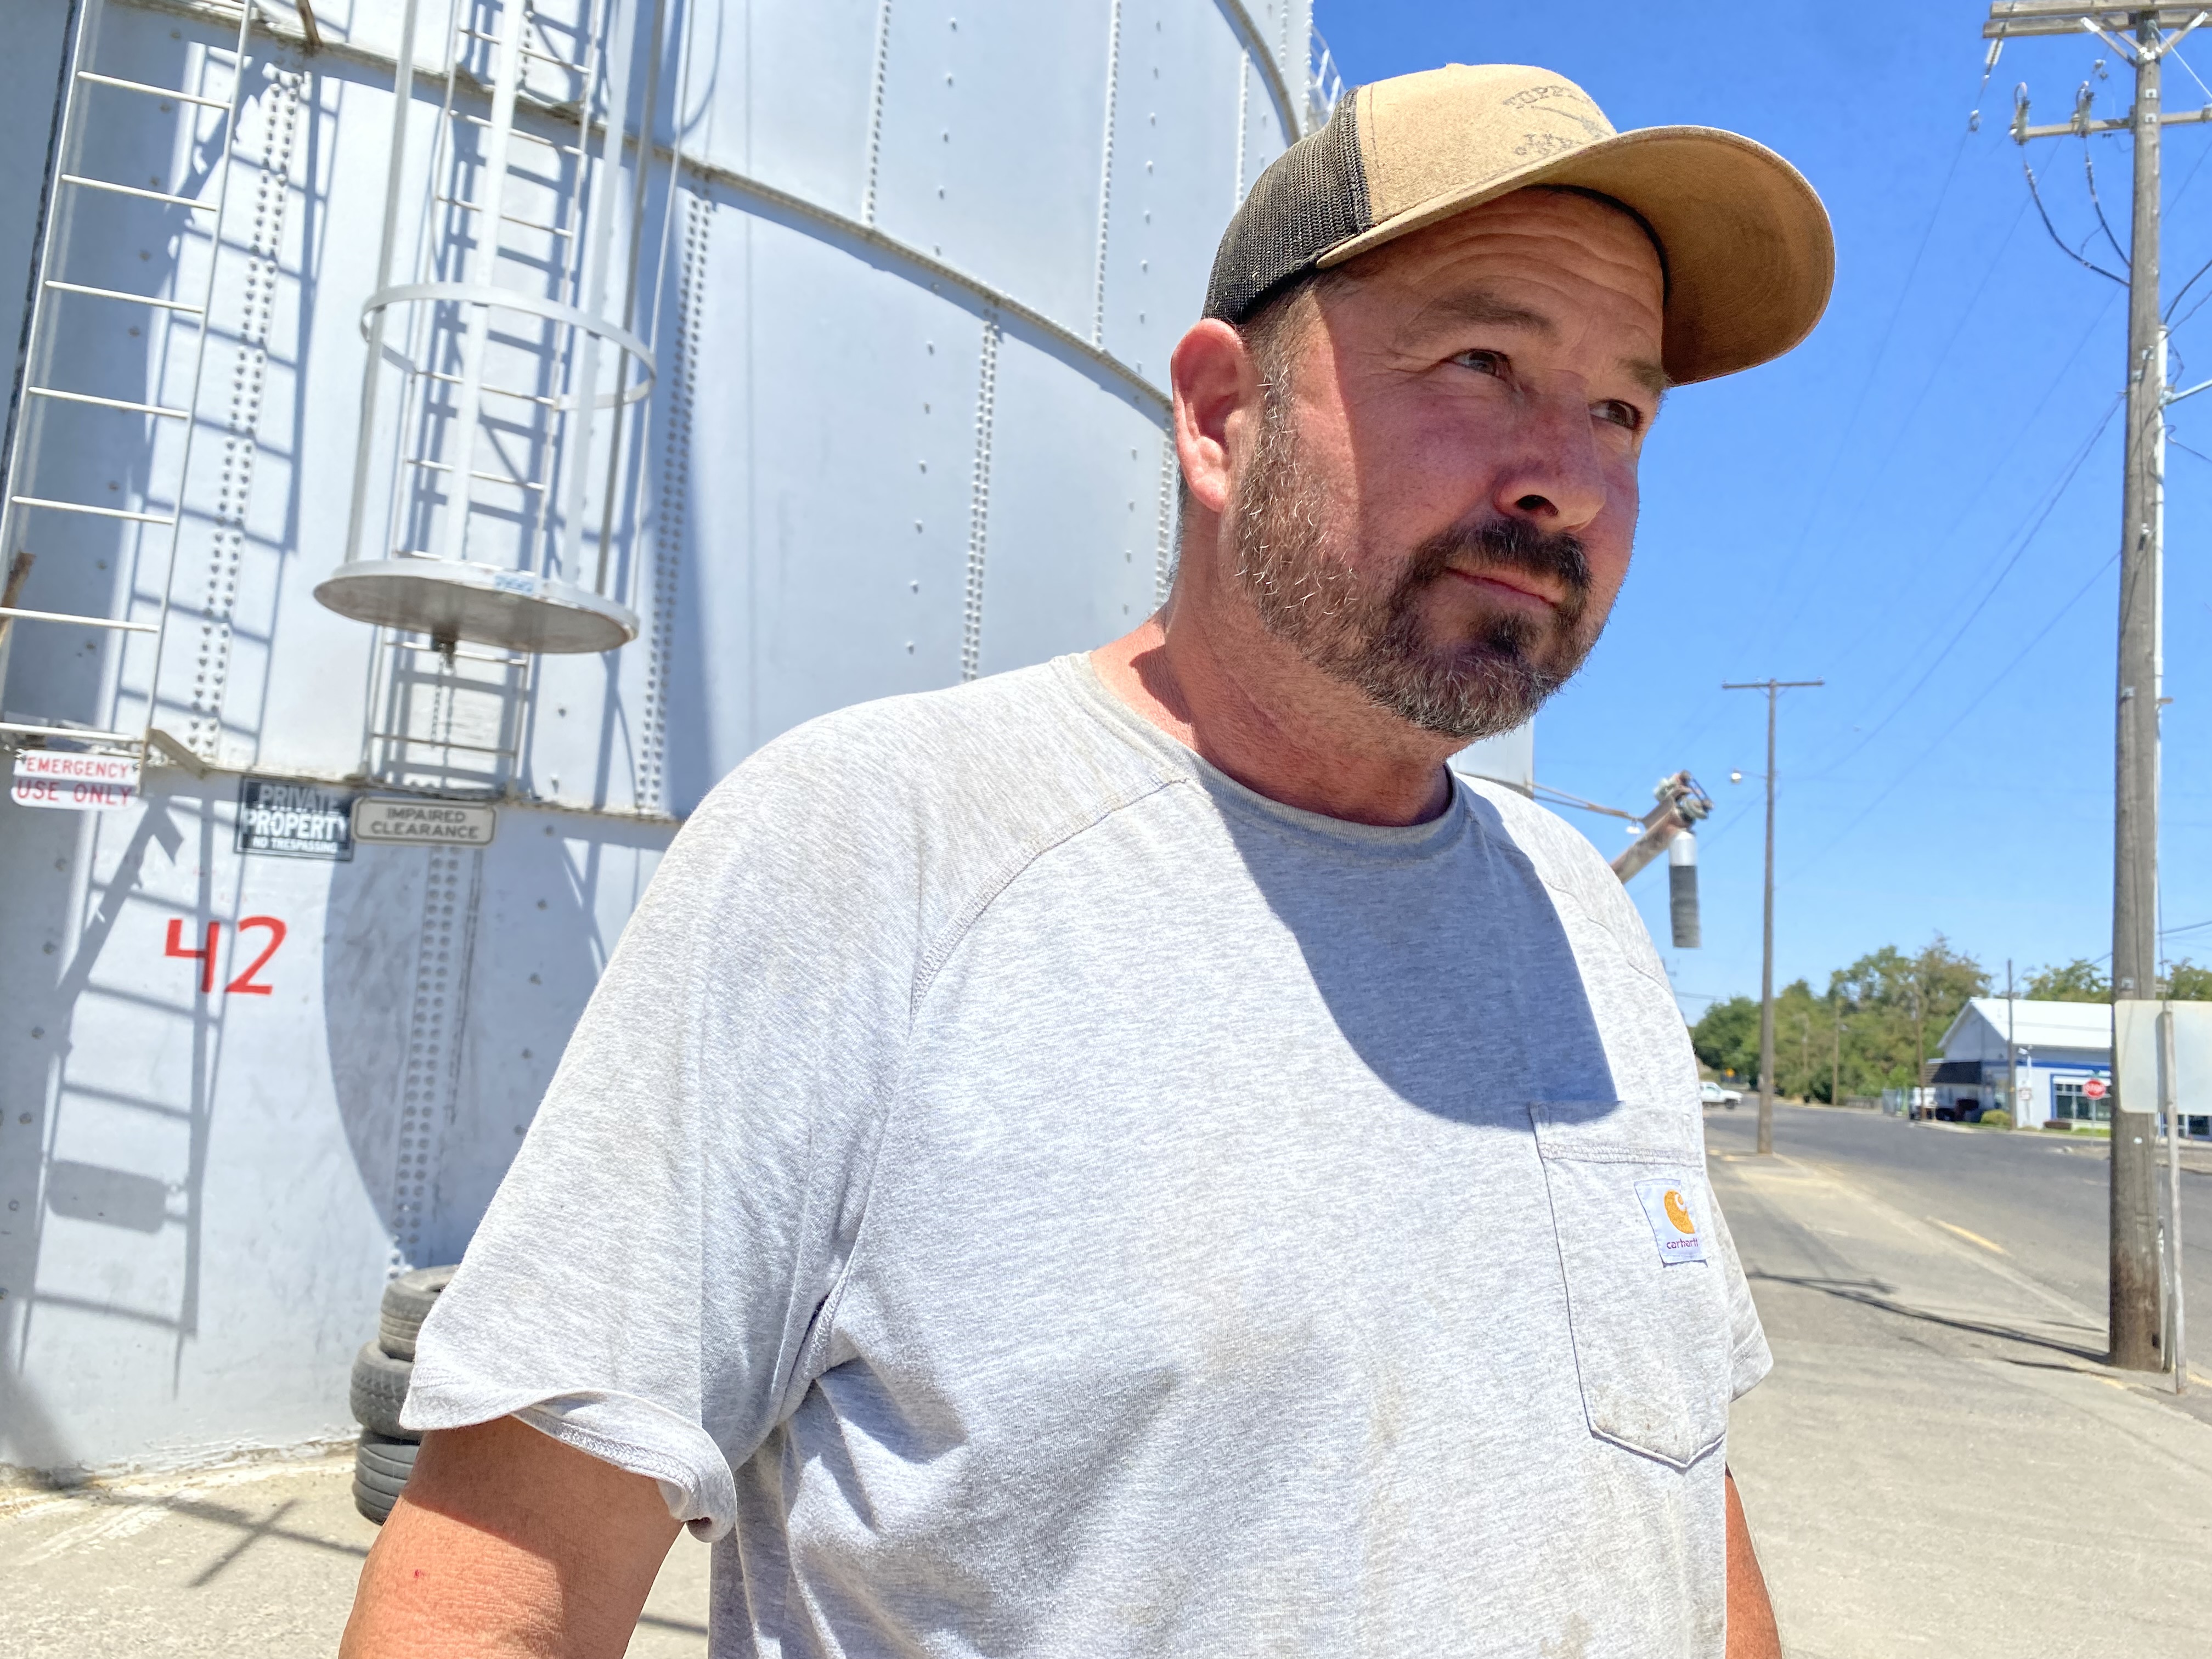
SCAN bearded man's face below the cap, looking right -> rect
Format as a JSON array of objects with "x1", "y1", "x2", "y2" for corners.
[{"x1": 1230, "y1": 190, "x2": 1663, "y2": 739}]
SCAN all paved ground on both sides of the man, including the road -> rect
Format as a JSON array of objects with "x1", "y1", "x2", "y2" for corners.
[{"x1": 0, "y1": 1106, "x2": 2212, "y2": 1659}]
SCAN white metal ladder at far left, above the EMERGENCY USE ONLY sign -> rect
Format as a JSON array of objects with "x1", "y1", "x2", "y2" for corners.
[{"x1": 0, "y1": 0, "x2": 255, "y2": 759}]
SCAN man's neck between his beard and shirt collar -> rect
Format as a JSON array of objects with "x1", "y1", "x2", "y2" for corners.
[{"x1": 1091, "y1": 553, "x2": 1460, "y2": 825}]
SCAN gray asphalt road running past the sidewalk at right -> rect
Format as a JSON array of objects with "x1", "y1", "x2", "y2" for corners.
[{"x1": 1706, "y1": 1099, "x2": 2212, "y2": 1372}]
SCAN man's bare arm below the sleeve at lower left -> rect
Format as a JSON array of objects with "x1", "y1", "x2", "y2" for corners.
[{"x1": 338, "y1": 1418, "x2": 676, "y2": 1659}]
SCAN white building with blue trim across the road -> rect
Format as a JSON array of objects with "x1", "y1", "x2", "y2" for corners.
[{"x1": 1929, "y1": 997, "x2": 2113, "y2": 1124}]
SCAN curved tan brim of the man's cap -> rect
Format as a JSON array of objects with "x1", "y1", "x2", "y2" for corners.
[{"x1": 1318, "y1": 126, "x2": 1836, "y2": 385}]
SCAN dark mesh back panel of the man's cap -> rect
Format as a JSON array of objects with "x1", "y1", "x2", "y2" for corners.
[{"x1": 1205, "y1": 93, "x2": 1374, "y2": 323}]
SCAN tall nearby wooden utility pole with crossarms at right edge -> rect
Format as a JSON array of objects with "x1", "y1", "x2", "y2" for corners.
[{"x1": 1982, "y1": 0, "x2": 2185, "y2": 1372}]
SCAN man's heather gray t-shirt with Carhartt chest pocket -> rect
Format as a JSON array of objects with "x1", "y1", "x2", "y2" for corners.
[{"x1": 405, "y1": 657, "x2": 1770, "y2": 1659}]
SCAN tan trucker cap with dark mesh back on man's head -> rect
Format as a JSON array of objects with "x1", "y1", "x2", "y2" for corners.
[{"x1": 1205, "y1": 64, "x2": 1836, "y2": 383}]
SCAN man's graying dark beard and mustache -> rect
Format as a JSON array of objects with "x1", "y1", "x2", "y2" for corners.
[{"x1": 1234, "y1": 387, "x2": 1604, "y2": 741}]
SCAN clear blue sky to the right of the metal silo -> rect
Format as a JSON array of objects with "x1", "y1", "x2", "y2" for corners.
[{"x1": 1316, "y1": 0, "x2": 2212, "y2": 1018}]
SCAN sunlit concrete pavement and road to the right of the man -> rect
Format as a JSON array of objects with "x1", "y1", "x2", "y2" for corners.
[{"x1": 1708, "y1": 1108, "x2": 2212, "y2": 1659}]
